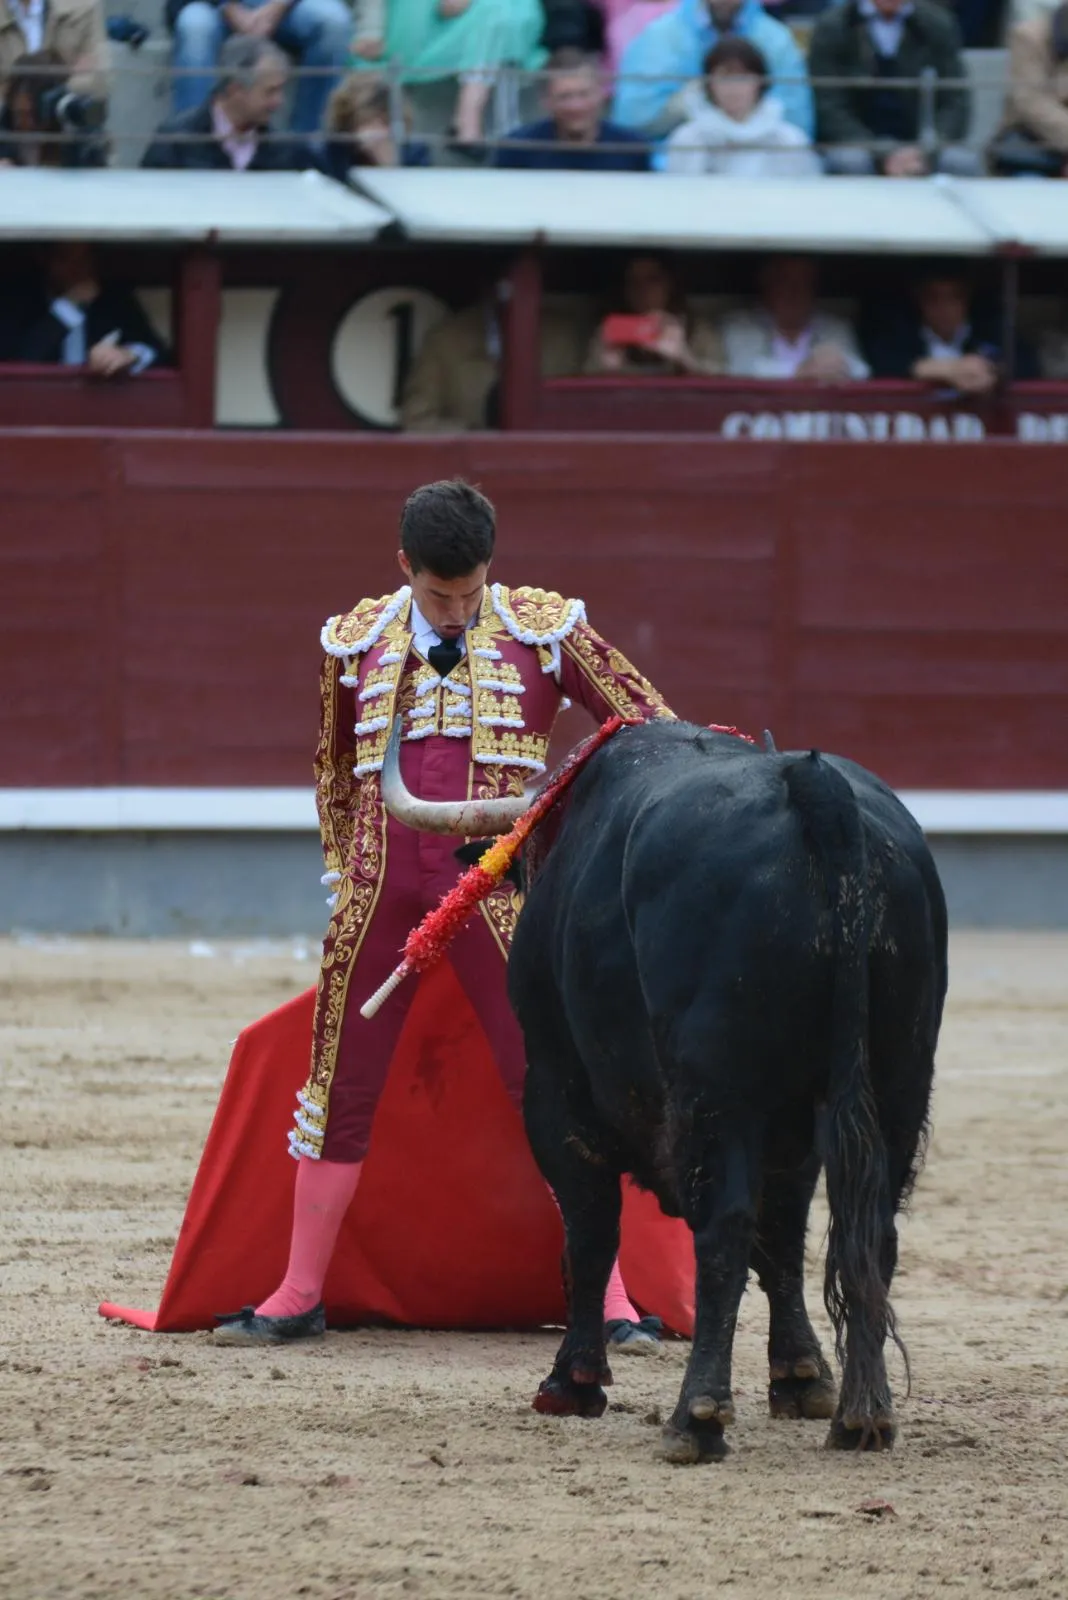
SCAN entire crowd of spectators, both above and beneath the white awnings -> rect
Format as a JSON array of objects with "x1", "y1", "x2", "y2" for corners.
[{"x1": 0, "y1": 0, "x2": 1068, "y2": 396}]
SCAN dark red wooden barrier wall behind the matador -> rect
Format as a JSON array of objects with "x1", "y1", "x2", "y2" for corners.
[{"x1": 0, "y1": 430, "x2": 1068, "y2": 789}]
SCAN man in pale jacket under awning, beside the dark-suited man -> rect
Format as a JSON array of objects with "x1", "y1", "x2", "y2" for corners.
[{"x1": 721, "y1": 256, "x2": 868, "y2": 384}]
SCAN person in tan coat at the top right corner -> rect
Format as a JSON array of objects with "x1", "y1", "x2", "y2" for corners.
[{"x1": 990, "y1": 5, "x2": 1068, "y2": 178}]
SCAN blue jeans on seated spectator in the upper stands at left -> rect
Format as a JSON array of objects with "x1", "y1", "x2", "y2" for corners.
[{"x1": 174, "y1": 0, "x2": 346, "y2": 134}]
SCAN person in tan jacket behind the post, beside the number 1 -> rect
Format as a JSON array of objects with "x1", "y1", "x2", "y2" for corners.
[{"x1": 401, "y1": 288, "x2": 582, "y2": 434}]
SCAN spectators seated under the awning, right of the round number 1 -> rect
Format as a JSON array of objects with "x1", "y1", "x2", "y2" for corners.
[{"x1": 394, "y1": 254, "x2": 1052, "y2": 434}]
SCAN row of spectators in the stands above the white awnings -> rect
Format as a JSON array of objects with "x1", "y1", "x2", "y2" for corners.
[{"x1": 0, "y1": 0, "x2": 1068, "y2": 179}]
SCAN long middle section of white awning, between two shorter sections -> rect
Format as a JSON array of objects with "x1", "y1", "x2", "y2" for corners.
[{"x1": 350, "y1": 166, "x2": 991, "y2": 256}]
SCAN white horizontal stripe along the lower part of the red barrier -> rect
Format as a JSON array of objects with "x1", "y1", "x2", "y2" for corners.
[{"x1": 0, "y1": 787, "x2": 1068, "y2": 834}]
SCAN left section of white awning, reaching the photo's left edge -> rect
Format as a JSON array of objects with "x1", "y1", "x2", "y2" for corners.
[{"x1": 0, "y1": 166, "x2": 392, "y2": 245}]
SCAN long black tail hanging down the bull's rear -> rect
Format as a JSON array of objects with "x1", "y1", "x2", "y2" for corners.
[{"x1": 783, "y1": 750, "x2": 908, "y2": 1432}]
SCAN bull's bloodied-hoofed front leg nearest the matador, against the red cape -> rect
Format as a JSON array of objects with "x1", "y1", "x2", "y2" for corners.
[{"x1": 523, "y1": 1054, "x2": 622, "y2": 1416}]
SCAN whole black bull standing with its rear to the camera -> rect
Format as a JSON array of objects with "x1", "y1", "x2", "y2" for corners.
[{"x1": 508, "y1": 722, "x2": 946, "y2": 1462}]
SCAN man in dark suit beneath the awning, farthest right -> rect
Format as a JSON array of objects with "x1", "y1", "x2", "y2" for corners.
[{"x1": 868, "y1": 264, "x2": 1038, "y2": 395}]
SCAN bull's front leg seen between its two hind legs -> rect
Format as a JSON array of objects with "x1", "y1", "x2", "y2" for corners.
[{"x1": 751, "y1": 1123, "x2": 838, "y2": 1418}]
